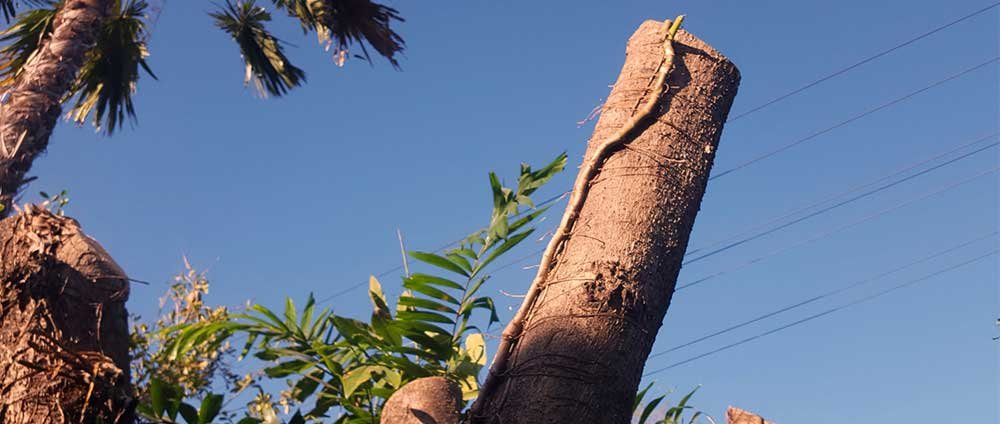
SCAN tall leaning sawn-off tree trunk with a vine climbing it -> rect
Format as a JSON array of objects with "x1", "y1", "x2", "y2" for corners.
[{"x1": 473, "y1": 21, "x2": 740, "y2": 424}]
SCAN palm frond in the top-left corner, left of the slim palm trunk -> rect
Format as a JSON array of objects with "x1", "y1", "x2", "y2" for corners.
[{"x1": 0, "y1": 3, "x2": 58, "y2": 86}]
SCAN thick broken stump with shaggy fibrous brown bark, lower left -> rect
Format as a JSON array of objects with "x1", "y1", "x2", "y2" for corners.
[{"x1": 0, "y1": 206, "x2": 134, "y2": 424}]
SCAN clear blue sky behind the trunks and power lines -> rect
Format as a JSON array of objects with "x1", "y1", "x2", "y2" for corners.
[{"x1": 31, "y1": 0, "x2": 1000, "y2": 423}]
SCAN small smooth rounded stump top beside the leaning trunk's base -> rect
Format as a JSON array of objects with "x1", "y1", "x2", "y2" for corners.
[{"x1": 382, "y1": 377, "x2": 463, "y2": 424}]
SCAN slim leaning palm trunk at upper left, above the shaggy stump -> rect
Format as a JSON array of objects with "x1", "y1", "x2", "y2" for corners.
[{"x1": 0, "y1": 0, "x2": 113, "y2": 218}]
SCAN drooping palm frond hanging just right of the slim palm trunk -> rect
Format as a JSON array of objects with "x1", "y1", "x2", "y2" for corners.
[{"x1": 67, "y1": 0, "x2": 156, "y2": 135}]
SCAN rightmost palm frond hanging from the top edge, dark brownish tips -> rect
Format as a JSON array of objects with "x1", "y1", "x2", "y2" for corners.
[{"x1": 272, "y1": 0, "x2": 405, "y2": 68}]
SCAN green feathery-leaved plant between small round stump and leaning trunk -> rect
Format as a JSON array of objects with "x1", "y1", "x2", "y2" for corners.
[{"x1": 163, "y1": 155, "x2": 566, "y2": 423}]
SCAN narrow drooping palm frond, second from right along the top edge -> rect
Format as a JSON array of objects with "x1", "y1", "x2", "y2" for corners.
[{"x1": 210, "y1": 0, "x2": 306, "y2": 96}]
